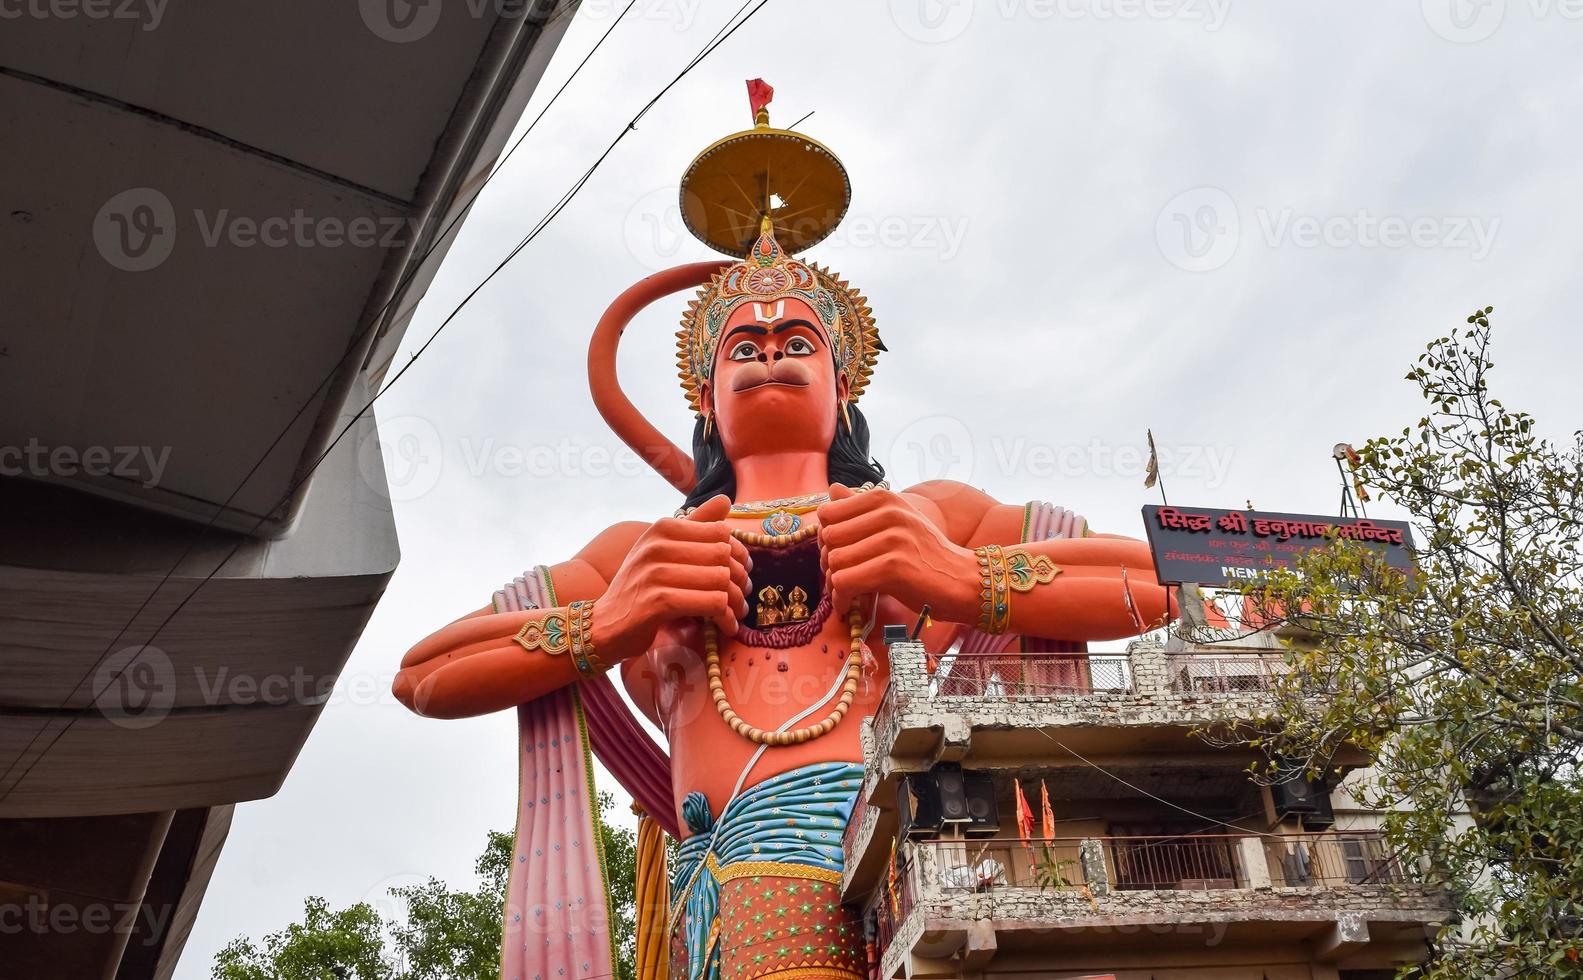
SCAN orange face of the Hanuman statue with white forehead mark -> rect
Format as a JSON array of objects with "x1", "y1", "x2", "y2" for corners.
[{"x1": 704, "y1": 299, "x2": 844, "y2": 459}]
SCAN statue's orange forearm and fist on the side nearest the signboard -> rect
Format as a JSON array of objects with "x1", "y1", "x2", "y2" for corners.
[{"x1": 820, "y1": 481, "x2": 1170, "y2": 640}]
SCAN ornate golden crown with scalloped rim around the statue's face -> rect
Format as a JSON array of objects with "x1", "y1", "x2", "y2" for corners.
[{"x1": 676, "y1": 217, "x2": 885, "y2": 415}]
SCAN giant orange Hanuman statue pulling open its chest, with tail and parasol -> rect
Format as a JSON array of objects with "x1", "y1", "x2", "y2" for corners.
[{"x1": 396, "y1": 84, "x2": 1168, "y2": 980}]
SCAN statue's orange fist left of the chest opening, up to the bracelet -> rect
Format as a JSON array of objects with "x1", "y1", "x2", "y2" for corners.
[{"x1": 594, "y1": 496, "x2": 752, "y2": 660}]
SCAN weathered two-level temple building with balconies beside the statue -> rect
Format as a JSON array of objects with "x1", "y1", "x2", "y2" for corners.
[{"x1": 844, "y1": 595, "x2": 1450, "y2": 980}]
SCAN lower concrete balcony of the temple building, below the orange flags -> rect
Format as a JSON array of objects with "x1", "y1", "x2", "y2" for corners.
[{"x1": 864, "y1": 831, "x2": 1450, "y2": 980}]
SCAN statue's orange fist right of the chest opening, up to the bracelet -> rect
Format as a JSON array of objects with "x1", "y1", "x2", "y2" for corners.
[{"x1": 818, "y1": 484, "x2": 978, "y2": 622}]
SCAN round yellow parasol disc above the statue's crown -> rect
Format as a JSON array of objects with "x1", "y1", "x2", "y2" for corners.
[{"x1": 681, "y1": 109, "x2": 852, "y2": 258}]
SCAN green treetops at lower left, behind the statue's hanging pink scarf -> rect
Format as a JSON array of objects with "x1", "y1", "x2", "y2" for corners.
[{"x1": 211, "y1": 793, "x2": 638, "y2": 980}]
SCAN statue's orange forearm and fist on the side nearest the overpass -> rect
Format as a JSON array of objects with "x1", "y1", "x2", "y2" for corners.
[{"x1": 393, "y1": 499, "x2": 747, "y2": 717}]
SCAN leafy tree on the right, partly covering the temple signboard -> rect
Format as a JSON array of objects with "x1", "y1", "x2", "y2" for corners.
[{"x1": 1203, "y1": 309, "x2": 1583, "y2": 980}]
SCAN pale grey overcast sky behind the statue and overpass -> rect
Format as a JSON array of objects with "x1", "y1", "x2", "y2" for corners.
[{"x1": 177, "y1": 0, "x2": 1583, "y2": 980}]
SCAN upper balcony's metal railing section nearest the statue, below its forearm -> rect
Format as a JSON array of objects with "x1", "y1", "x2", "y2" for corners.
[{"x1": 929, "y1": 654, "x2": 1132, "y2": 701}]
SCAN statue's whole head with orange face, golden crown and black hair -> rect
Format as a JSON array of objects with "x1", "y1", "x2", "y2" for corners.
[{"x1": 678, "y1": 218, "x2": 883, "y2": 503}]
